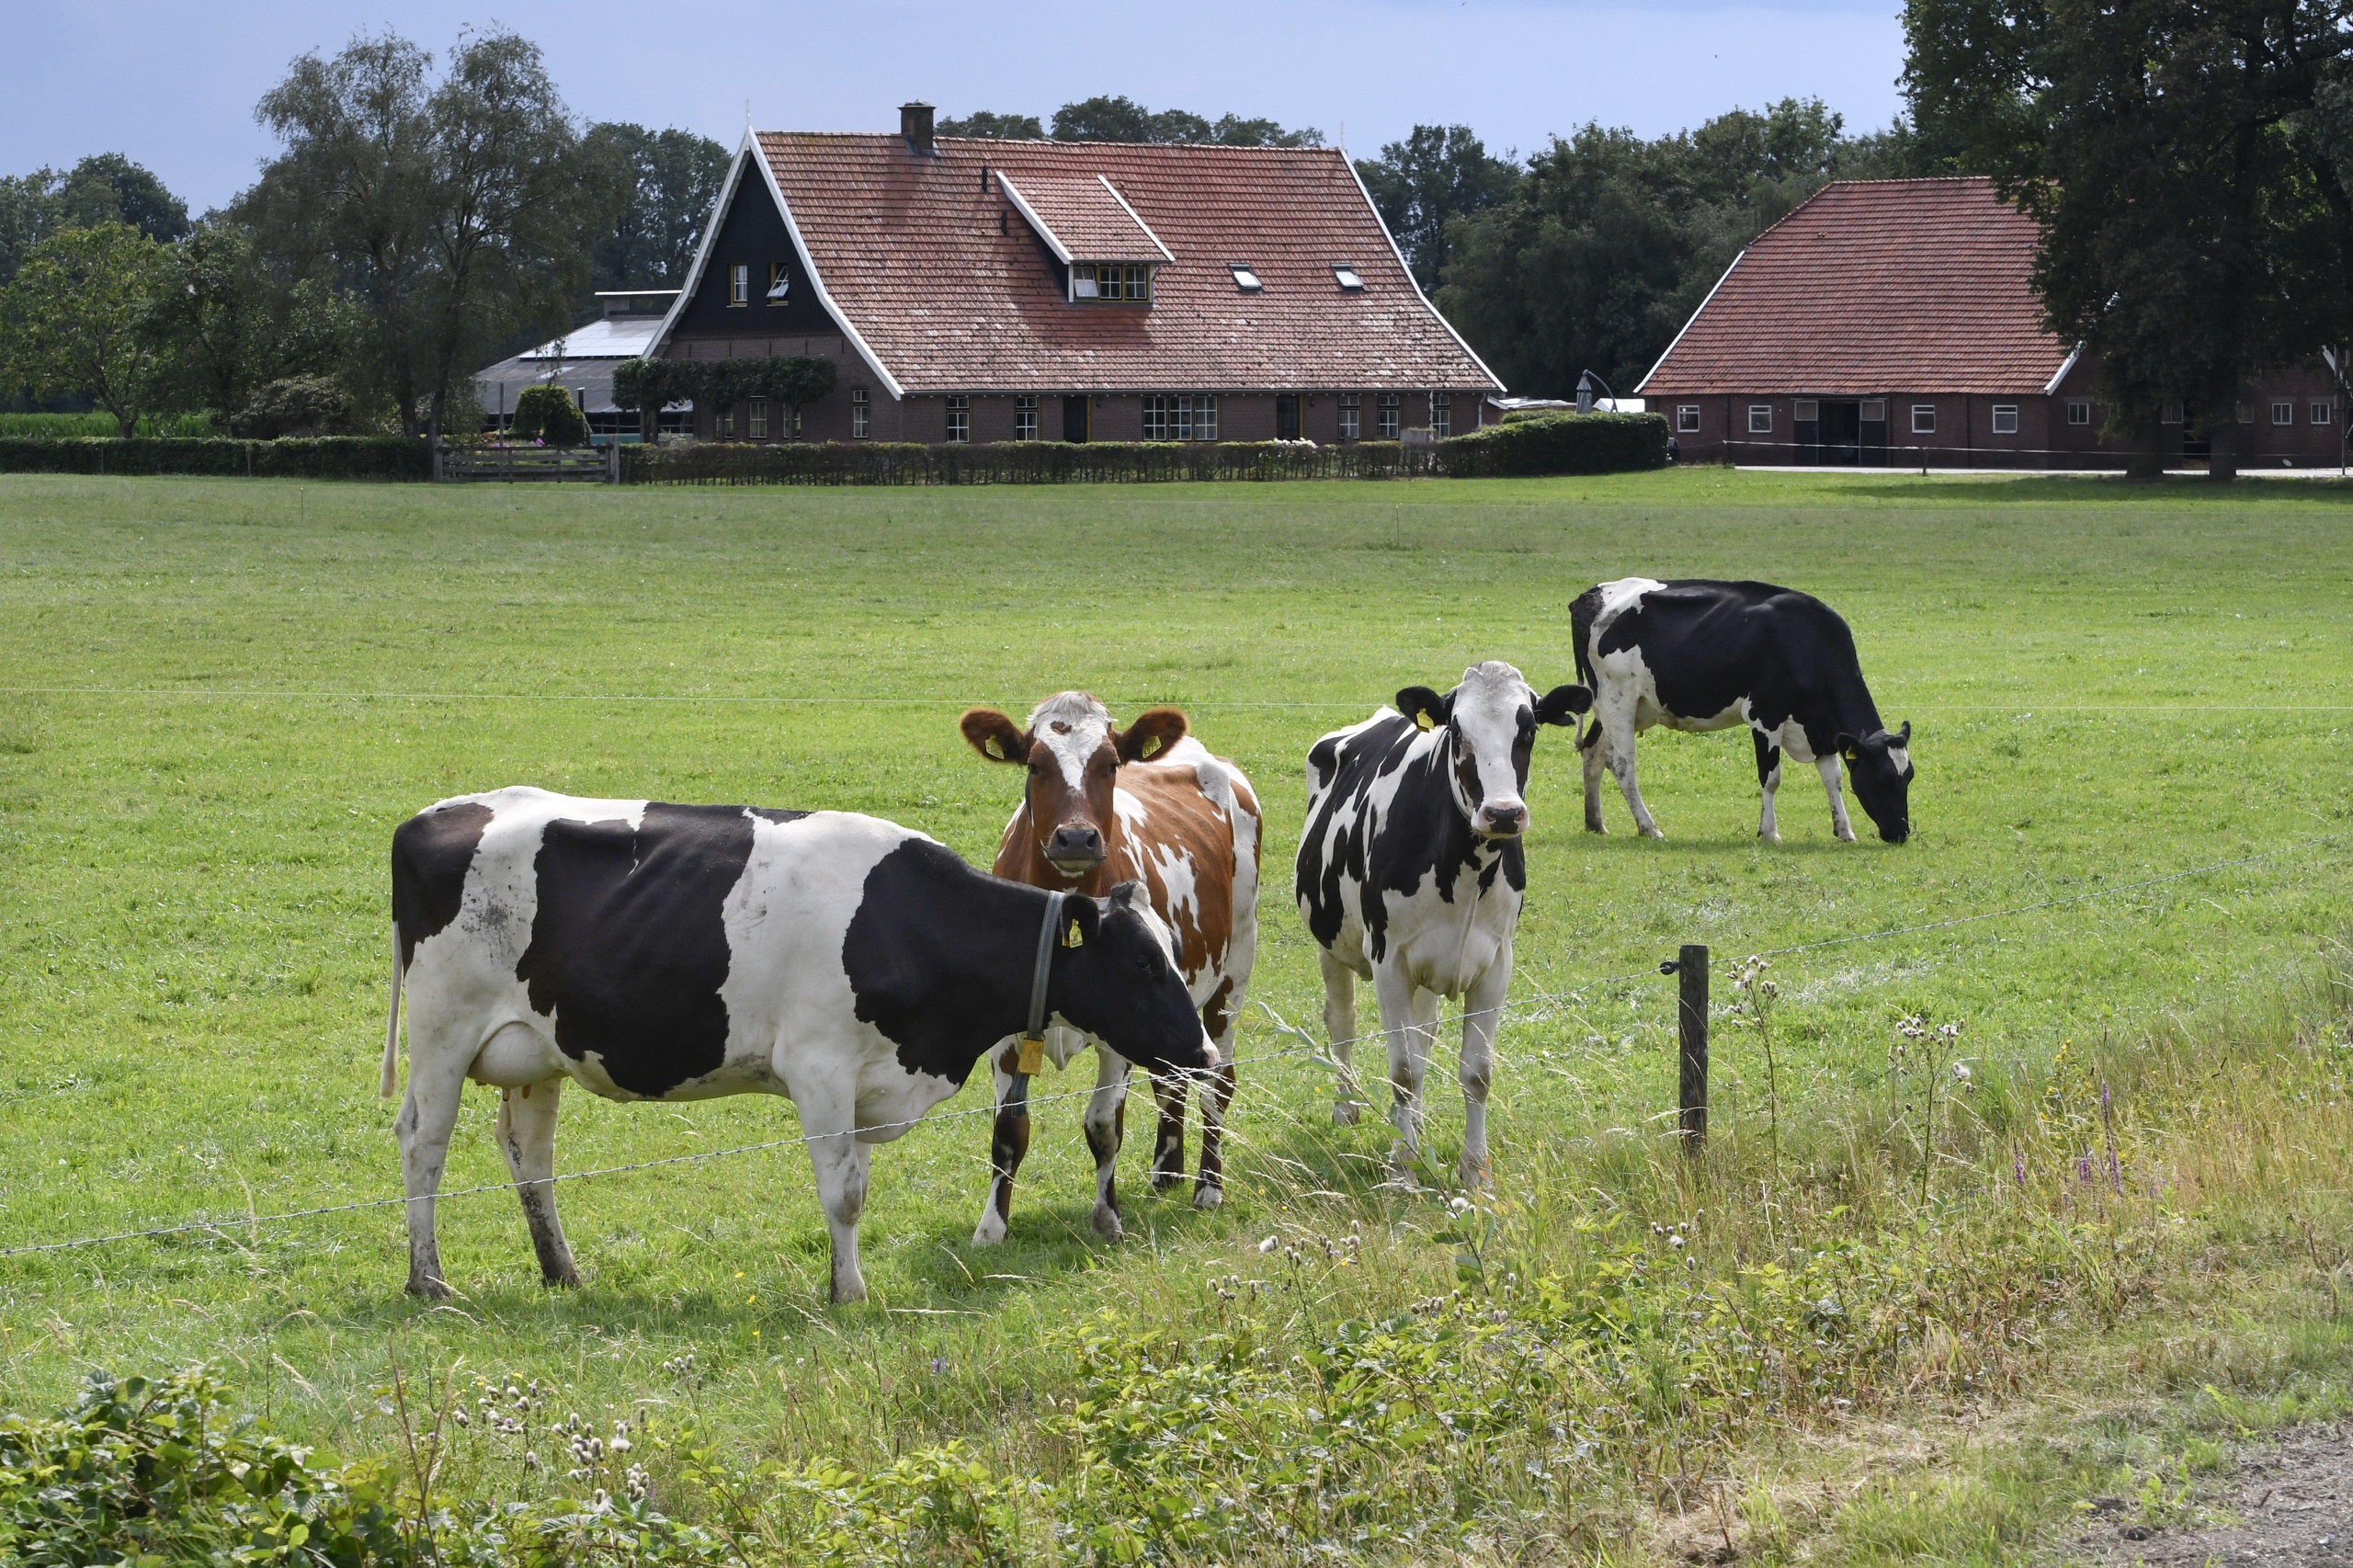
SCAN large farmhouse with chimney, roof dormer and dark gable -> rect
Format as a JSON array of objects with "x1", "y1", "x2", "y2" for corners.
[{"x1": 652, "y1": 104, "x2": 1504, "y2": 443}]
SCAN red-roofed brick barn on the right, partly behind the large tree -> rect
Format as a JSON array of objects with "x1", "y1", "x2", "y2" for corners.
[{"x1": 1638, "y1": 179, "x2": 2346, "y2": 469}]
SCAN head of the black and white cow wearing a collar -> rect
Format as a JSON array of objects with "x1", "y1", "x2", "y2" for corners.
[{"x1": 1047, "y1": 883, "x2": 1217, "y2": 1074}]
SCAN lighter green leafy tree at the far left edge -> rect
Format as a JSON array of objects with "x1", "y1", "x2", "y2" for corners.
[{"x1": 0, "y1": 223, "x2": 169, "y2": 440}]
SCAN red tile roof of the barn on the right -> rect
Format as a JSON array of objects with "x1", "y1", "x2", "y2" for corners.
[{"x1": 1638, "y1": 176, "x2": 2068, "y2": 398}]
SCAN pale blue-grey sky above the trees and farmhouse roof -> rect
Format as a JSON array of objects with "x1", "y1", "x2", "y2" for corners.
[{"x1": 14, "y1": 0, "x2": 1904, "y2": 212}]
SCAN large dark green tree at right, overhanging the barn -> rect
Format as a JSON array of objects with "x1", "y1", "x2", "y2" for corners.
[{"x1": 1904, "y1": 0, "x2": 2353, "y2": 478}]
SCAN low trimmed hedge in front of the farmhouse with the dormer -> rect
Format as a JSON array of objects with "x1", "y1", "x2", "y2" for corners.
[{"x1": 621, "y1": 415, "x2": 1665, "y2": 485}]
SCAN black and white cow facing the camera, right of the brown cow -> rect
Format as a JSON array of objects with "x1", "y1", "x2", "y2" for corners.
[{"x1": 1294, "y1": 659, "x2": 1591, "y2": 1182}]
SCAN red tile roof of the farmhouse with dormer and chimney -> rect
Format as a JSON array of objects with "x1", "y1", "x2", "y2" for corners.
[{"x1": 757, "y1": 131, "x2": 1501, "y2": 391}]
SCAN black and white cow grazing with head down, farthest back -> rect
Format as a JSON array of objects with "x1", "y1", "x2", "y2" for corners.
[{"x1": 1570, "y1": 577, "x2": 1913, "y2": 843}]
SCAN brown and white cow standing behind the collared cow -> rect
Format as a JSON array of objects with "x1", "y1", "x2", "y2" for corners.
[{"x1": 960, "y1": 692, "x2": 1261, "y2": 1245}]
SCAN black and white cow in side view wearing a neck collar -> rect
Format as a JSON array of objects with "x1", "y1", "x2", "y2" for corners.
[{"x1": 383, "y1": 789, "x2": 1217, "y2": 1302}]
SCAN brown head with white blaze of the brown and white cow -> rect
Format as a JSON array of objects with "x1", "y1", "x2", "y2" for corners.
[{"x1": 960, "y1": 692, "x2": 1186, "y2": 883}]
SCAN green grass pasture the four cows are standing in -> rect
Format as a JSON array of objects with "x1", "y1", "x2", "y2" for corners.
[{"x1": 0, "y1": 471, "x2": 2353, "y2": 1561}]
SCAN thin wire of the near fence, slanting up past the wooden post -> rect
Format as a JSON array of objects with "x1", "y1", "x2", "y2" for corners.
[{"x1": 0, "y1": 829, "x2": 2353, "y2": 1259}]
